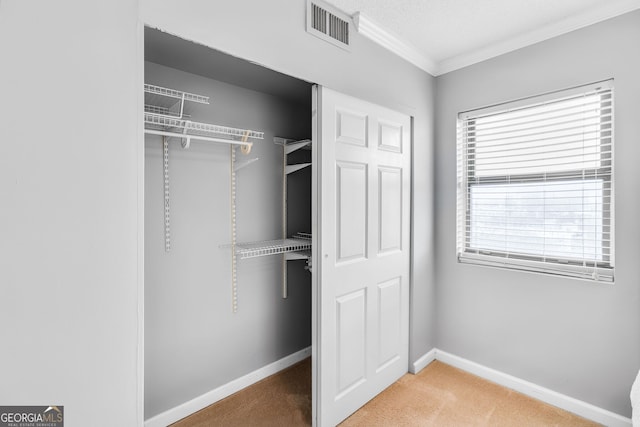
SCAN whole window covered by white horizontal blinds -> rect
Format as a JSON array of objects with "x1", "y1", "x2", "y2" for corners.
[{"x1": 457, "y1": 80, "x2": 614, "y2": 282}]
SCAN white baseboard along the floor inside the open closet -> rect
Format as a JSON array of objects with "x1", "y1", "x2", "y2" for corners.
[{"x1": 144, "y1": 347, "x2": 311, "y2": 427}]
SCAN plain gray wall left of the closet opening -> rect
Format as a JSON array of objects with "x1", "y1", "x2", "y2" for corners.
[{"x1": 0, "y1": 0, "x2": 142, "y2": 427}]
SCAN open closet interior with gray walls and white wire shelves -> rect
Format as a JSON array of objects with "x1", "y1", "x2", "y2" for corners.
[{"x1": 144, "y1": 28, "x2": 313, "y2": 419}]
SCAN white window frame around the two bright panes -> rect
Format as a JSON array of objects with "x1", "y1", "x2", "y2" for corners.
[{"x1": 456, "y1": 79, "x2": 615, "y2": 283}]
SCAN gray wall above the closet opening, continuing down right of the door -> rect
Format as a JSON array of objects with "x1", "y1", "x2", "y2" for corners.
[{"x1": 141, "y1": 0, "x2": 435, "y2": 372}]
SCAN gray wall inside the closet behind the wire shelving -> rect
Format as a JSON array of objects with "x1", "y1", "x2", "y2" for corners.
[{"x1": 145, "y1": 62, "x2": 311, "y2": 418}]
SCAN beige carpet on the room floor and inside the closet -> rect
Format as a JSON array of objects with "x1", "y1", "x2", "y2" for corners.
[{"x1": 173, "y1": 359, "x2": 598, "y2": 427}]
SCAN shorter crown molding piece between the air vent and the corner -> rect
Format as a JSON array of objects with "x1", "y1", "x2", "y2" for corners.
[{"x1": 353, "y1": 12, "x2": 436, "y2": 75}]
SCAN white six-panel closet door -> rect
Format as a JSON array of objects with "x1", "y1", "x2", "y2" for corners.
[{"x1": 313, "y1": 87, "x2": 411, "y2": 426}]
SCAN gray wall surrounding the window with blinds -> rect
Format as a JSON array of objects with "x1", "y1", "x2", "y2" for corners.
[{"x1": 435, "y1": 12, "x2": 640, "y2": 416}]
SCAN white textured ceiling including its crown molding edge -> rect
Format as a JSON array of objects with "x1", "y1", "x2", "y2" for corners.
[{"x1": 328, "y1": 0, "x2": 640, "y2": 75}]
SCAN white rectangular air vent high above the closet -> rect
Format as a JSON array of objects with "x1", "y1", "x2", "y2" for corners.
[{"x1": 307, "y1": 0, "x2": 351, "y2": 50}]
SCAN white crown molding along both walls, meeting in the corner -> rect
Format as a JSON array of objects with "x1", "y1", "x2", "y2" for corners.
[{"x1": 353, "y1": 0, "x2": 640, "y2": 76}]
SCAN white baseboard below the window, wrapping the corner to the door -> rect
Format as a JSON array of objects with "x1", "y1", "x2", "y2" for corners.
[{"x1": 412, "y1": 348, "x2": 631, "y2": 427}]
